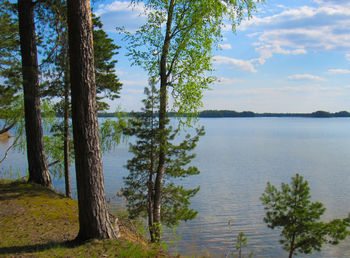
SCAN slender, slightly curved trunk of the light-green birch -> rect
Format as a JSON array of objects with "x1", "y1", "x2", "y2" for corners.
[{"x1": 153, "y1": 0, "x2": 175, "y2": 242}]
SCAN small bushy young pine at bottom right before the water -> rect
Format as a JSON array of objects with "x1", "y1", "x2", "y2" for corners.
[{"x1": 261, "y1": 174, "x2": 350, "y2": 258}]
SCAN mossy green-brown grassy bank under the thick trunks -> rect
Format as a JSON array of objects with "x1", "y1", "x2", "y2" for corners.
[{"x1": 0, "y1": 180, "x2": 167, "y2": 257}]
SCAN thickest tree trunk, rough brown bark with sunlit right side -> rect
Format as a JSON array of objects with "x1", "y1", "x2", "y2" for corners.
[{"x1": 68, "y1": 0, "x2": 116, "y2": 241}]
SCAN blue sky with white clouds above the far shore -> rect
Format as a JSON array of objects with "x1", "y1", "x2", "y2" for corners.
[{"x1": 94, "y1": 0, "x2": 350, "y2": 112}]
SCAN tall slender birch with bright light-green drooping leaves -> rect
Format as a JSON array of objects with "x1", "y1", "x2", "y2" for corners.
[{"x1": 126, "y1": 0, "x2": 259, "y2": 238}]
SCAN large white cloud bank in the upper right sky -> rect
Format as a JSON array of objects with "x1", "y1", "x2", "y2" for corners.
[{"x1": 239, "y1": 0, "x2": 350, "y2": 64}]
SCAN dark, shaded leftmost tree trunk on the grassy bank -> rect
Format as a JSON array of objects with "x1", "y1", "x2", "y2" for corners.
[{"x1": 18, "y1": 0, "x2": 52, "y2": 188}]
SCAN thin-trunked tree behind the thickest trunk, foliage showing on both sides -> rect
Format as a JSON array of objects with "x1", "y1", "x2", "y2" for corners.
[{"x1": 38, "y1": 0, "x2": 121, "y2": 198}]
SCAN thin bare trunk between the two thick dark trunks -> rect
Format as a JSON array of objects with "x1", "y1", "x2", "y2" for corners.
[{"x1": 63, "y1": 58, "x2": 72, "y2": 198}]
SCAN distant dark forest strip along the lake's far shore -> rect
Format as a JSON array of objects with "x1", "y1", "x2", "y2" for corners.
[{"x1": 98, "y1": 110, "x2": 350, "y2": 118}]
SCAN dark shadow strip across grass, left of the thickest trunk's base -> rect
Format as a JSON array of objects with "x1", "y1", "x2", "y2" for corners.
[{"x1": 0, "y1": 241, "x2": 83, "y2": 255}]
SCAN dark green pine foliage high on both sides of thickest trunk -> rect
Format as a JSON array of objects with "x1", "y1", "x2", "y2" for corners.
[{"x1": 37, "y1": 0, "x2": 122, "y2": 110}]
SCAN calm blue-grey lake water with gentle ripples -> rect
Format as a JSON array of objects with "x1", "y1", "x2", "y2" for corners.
[{"x1": 0, "y1": 118, "x2": 350, "y2": 257}]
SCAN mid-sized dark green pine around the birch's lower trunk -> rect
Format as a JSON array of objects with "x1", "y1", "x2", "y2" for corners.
[{"x1": 123, "y1": 84, "x2": 204, "y2": 242}]
